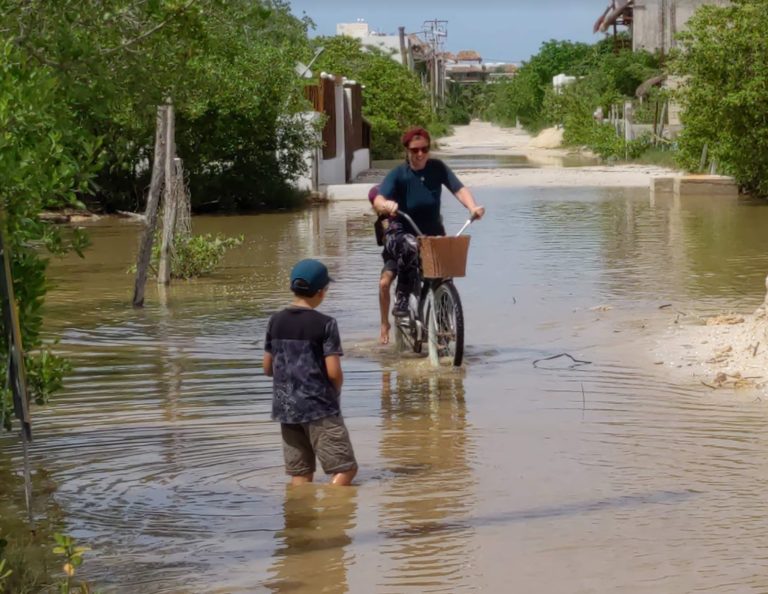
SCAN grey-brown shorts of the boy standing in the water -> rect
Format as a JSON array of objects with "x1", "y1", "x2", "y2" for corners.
[{"x1": 280, "y1": 416, "x2": 357, "y2": 476}]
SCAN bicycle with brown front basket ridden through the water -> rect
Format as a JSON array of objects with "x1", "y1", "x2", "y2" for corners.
[{"x1": 395, "y1": 212, "x2": 474, "y2": 367}]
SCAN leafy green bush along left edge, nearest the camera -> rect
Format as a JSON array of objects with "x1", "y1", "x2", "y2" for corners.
[{"x1": 0, "y1": 42, "x2": 100, "y2": 428}]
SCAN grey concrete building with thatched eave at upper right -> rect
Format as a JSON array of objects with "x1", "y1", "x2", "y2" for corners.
[{"x1": 593, "y1": 0, "x2": 730, "y2": 54}]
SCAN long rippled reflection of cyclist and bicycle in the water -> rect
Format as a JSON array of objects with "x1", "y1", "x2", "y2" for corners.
[{"x1": 379, "y1": 372, "x2": 474, "y2": 592}]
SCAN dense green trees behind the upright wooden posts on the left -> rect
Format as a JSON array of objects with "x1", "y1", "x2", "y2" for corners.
[{"x1": 0, "y1": 0, "x2": 312, "y2": 210}]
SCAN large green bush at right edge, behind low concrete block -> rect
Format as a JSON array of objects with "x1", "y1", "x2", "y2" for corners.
[{"x1": 672, "y1": 0, "x2": 768, "y2": 196}]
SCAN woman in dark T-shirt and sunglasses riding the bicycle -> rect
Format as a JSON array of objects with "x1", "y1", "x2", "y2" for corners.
[{"x1": 372, "y1": 127, "x2": 485, "y2": 344}]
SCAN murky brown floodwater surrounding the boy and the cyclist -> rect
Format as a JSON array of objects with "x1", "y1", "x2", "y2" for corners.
[{"x1": 0, "y1": 183, "x2": 768, "y2": 594}]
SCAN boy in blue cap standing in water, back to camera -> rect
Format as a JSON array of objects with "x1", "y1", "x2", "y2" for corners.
[{"x1": 264, "y1": 260, "x2": 357, "y2": 485}]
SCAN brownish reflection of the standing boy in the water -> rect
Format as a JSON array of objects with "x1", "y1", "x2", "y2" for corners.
[{"x1": 265, "y1": 485, "x2": 357, "y2": 594}]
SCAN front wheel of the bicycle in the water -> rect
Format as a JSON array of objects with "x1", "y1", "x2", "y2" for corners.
[{"x1": 427, "y1": 281, "x2": 464, "y2": 367}]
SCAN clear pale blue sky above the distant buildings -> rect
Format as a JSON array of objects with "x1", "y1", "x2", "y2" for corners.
[{"x1": 289, "y1": 0, "x2": 609, "y2": 62}]
